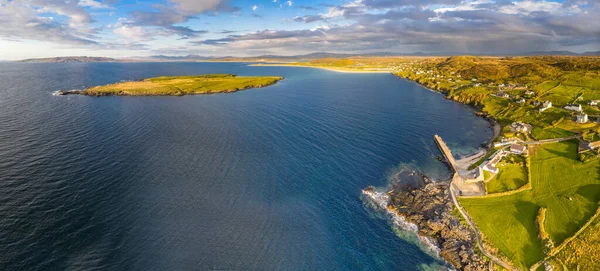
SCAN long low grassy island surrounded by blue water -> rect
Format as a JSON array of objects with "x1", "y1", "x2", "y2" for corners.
[{"x1": 56, "y1": 74, "x2": 283, "y2": 96}]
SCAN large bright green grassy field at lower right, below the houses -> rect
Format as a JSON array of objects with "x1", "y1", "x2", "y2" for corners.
[{"x1": 460, "y1": 140, "x2": 600, "y2": 268}]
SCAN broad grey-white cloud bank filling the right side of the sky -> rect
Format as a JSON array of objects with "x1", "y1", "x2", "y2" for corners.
[{"x1": 199, "y1": 0, "x2": 600, "y2": 53}]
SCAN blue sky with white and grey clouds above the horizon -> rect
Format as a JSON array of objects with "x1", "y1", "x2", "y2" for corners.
[{"x1": 0, "y1": 0, "x2": 600, "y2": 60}]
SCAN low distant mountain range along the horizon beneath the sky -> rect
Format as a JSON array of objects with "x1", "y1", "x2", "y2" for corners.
[{"x1": 18, "y1": 51, "x2": 600, "y2": 62}]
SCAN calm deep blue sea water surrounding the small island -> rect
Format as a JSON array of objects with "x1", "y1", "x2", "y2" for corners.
[{"x1": 0, "y1": 63, "x2": 491, "y2": 270}]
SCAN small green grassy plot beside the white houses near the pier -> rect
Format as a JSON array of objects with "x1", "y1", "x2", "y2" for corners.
[{"x1": 485, "y1": 155, "x2": 527, "y2": 194}]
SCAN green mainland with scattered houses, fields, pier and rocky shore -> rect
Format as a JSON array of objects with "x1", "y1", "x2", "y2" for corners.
[{"x1": 282, "y1": 56, "x2": 600, "y2": 270}]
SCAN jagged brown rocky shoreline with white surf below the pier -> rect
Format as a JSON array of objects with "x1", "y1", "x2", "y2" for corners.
[{"x1": 363, "y1": 168, "x2": 492, "y2": 270}]
